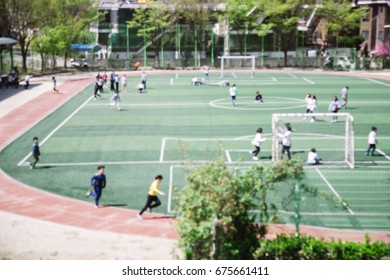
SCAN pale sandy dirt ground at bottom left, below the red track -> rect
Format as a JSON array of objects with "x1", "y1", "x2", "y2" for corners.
[{"x1": 0, "y1": 211, "x2": 178, "y2": 260}]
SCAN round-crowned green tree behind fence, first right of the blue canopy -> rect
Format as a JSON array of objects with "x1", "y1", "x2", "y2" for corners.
[{"x1": 127, "y1": 4, "x2": 172, "y2": 67}]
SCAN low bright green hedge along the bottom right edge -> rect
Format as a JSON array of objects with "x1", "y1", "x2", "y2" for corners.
[{"x1": 254, "y1": 234, "x2": 390, "y2": 260}]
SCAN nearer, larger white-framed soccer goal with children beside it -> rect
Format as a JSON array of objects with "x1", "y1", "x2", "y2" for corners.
[{"x1": 272, "y1": 113, "x2": 355, "y2": 168}]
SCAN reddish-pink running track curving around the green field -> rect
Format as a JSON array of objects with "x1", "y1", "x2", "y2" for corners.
[{"x1": 0, "y1": 70, "x2": 390, "y2": 248}]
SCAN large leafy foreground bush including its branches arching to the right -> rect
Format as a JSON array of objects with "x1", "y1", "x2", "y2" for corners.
[{"x1": 178, "y1": 159, "x2": 303, "y2": 259}]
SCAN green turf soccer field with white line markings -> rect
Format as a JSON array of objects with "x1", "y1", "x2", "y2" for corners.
[{"x1": 0, "y1": 72, "x2": 390, "y2": 231}]
